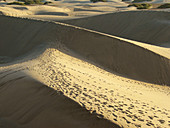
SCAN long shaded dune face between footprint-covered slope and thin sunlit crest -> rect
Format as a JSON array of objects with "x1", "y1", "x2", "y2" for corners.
[{"x1": 0, "y1": 16, "x2": 170, "y2": 85}]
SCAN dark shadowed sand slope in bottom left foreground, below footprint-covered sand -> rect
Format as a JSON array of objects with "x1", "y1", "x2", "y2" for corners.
[{"x1": 0, "y1": 75, "x2": 119, "y2": 128}]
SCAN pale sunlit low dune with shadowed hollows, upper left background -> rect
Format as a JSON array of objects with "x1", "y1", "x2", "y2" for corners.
[{"x1": 0, "y1": 5, "x2": 72, "y2": 17}]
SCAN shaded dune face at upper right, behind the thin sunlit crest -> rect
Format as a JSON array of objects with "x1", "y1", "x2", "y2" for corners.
[{"x1": 62, "y1": 11, "x2": 170, "y2": 45}]
